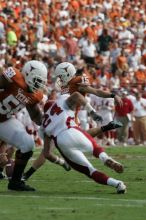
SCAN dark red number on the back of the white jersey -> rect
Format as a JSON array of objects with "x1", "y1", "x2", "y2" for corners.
[{"x1": 42, "y1": 104, "x2": 63, "y2": 128}]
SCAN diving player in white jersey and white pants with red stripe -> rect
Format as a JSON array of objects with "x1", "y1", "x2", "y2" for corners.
[{"x1": 42, "y1": 92, "x2": 126, "y2": 193}]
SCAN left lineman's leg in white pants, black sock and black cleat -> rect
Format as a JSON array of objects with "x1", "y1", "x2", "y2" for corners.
[{"x1": 0, "y1": 118, "x2": 34, "y2": 191}]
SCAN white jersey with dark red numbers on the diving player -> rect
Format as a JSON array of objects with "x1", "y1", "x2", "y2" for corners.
[{"x1": 42, "y1": 95, "x2": 77, "y2": 137}]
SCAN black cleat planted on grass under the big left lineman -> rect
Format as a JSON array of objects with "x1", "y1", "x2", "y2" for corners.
[{"x1": 8, "y1": 180, "x2": 35, "y2": 191}]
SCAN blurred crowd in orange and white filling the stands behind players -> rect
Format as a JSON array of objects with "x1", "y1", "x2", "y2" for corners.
[{"x1": 0, "y1": 0, "x2": 146, "y2": 144}]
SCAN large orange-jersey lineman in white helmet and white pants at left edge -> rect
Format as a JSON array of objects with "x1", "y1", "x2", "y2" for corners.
[{"x1": 0, "y1": 60, "x2": 47, "y2": 191}]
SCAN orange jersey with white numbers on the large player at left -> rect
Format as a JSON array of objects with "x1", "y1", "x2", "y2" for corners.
[{"x1": 0, "y1": 67, "x2": 43, "y2": 122}]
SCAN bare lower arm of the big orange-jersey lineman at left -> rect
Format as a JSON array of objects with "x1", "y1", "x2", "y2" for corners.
[{"x1": 26, "y1": 104, "x2": 43, "y2": 125}]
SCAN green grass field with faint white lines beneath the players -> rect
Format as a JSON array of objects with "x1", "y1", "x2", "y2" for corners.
[{"x1": 0, "y1": 146, "x2": 146, "y2": 220}]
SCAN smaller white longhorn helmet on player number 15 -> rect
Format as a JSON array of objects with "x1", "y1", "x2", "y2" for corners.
[{"x1": 55, "y1": 62, "x2": 76, "y2": 86}]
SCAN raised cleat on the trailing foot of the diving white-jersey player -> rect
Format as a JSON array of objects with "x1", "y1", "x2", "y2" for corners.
[{"x1": 104, "y1": 158, "x2": 124, "y2": 173}]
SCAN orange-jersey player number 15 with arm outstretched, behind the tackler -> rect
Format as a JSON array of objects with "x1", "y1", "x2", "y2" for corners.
[{"x1": 54, "y1": 62, "x2": 123, "y2": 128}]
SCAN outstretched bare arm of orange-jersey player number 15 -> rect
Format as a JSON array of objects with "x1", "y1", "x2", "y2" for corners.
[{"x1": 78, "y1": 85, "x2": 123, "y2": 106}]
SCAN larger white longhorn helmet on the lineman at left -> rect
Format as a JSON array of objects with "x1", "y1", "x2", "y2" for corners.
[{"x1": 22, "y1": 60, "x2": 48, "y2": 91}]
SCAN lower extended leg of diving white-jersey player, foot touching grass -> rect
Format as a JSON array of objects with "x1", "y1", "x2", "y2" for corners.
[{"x1": 56, "y1": 131, "x2": 126, "y2": 193}]
